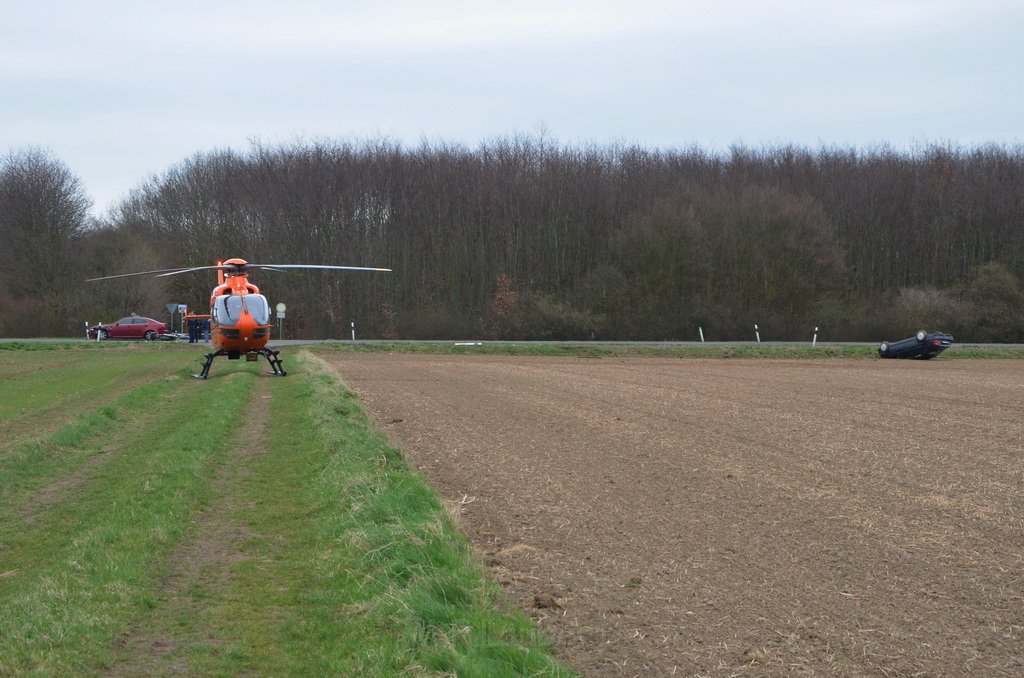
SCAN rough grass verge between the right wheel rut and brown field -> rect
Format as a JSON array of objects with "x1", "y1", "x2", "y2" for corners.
[{"x1": 190, "y1": 353, "x2": 570, "y2": 676}]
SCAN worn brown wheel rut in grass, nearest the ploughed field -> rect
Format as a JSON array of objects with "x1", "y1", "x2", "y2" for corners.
[{"x1": 102, "y1": 378, "x2": 272, "y2": 676}]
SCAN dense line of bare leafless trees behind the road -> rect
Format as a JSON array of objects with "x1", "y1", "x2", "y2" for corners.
[{"x1": 0, "y1": 135, "x2": 1024, "y2": 342}]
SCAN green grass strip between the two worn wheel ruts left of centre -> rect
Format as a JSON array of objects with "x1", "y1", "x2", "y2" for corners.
[{"x1": 0, "y1": 374, "x2": 252, "y2": 676}]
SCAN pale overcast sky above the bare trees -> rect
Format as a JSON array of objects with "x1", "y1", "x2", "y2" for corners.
[{"x1": 0, "y1": 0, "x2": 1024, "y2": 213}]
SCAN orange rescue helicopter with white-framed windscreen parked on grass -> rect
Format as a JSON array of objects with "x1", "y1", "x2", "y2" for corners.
[{"x1": 86, "y1": 259, "x2": 391, "y2": 379}]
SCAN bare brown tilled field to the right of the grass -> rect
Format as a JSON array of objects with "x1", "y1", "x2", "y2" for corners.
[{"x1": 322, "y1": 353, "x2": 1024, "y2": 676}]
